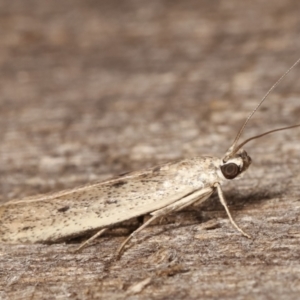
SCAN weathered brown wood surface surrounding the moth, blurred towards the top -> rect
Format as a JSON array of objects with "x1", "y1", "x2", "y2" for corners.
[{"x1": 0, "y1": 0, "x2": 300, "y2": 300}]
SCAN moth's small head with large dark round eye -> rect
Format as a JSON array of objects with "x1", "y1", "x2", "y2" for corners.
[{"x1": 220, "y1": 149, "x2": 252, "y2": 180}]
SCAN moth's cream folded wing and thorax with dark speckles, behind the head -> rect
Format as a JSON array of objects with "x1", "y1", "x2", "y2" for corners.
[{"x1": 0, "y1": 157, "x2": 221, "y2": 243}]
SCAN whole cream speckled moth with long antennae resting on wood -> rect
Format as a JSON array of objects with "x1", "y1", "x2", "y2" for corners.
[{"x1": 0, "y1": 59, "x2": 300, "y2": 254}]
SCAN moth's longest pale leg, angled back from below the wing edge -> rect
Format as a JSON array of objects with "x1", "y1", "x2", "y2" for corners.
[{"x1": 117, "y1": 188, "x2": 212, "y2": 257}]
